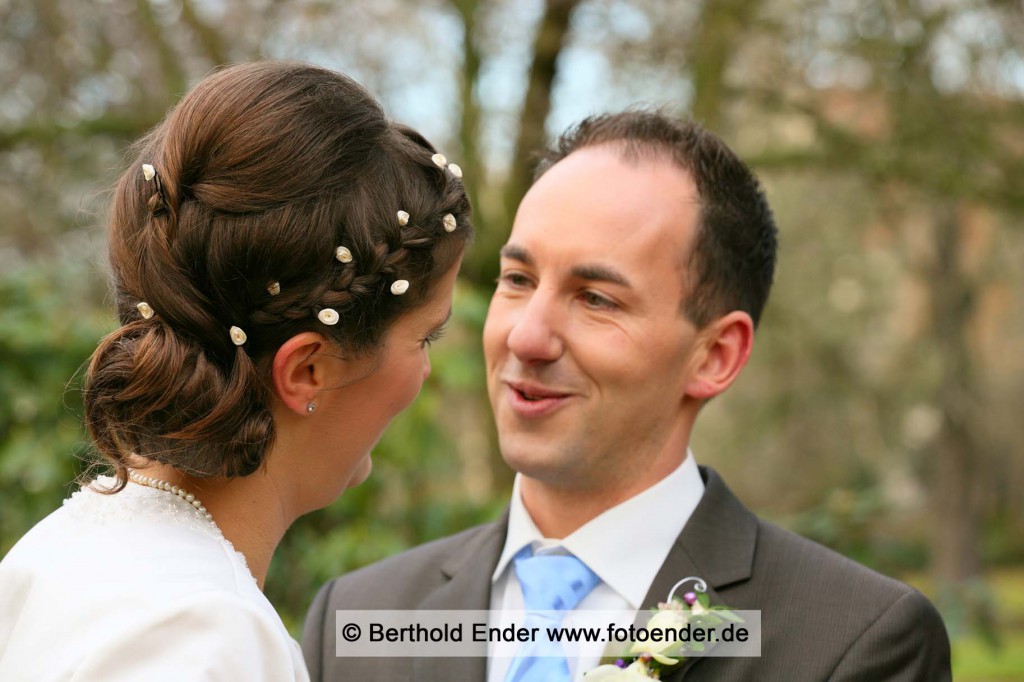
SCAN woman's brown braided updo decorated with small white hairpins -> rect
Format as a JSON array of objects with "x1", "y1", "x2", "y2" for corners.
[{"x1": 84, "y1": 61, "x2": 472, "y2": 485}]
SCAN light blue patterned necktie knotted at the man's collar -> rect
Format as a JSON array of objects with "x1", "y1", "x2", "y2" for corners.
[{"x1": 505, "y1": 547, "x2": 601, "y2": 682}]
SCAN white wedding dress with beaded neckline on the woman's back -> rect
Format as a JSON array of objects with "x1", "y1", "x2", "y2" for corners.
[{"x1": 0, "y1": 478, "x2": 309, "y2": 682}]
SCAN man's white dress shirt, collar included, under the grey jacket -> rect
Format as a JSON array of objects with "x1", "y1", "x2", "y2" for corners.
[{"x1": 487, "y1": 452, "x2": 703, "y2": 682}]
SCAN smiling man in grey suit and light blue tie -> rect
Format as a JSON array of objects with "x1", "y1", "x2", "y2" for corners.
[{"x1": 303, "y1": 112, "x2": 950, "y2": 682}]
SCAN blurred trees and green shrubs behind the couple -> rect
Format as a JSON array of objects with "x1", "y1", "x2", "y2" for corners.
[{"x1": 0, "y1": 0, "x2": 1024, "y2": 681}]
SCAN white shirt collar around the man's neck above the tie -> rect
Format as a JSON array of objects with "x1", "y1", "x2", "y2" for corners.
[{"x1": 492, "y1": 451, "x2": 703, "y2": 608}]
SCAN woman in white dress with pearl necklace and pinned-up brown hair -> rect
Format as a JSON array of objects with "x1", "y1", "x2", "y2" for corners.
[{"x1": 0, "y1": 61, "x2": 471, "y2": 682}]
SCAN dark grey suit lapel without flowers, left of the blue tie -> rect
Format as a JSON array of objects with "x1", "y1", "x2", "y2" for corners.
[{"x1": 413, "y1": 510, "x2": 508, "y2": 682}]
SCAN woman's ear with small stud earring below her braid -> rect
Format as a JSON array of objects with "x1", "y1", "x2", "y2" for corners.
[{"x1": 271, "y1": 332, "x2": 341, "y2": 416}]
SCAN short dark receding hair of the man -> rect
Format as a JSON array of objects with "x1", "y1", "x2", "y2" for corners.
[{"x1": 535, "y1": 111, "x2": 778, "y2": 328}]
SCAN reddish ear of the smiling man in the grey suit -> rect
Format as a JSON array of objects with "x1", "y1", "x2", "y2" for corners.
[{"x1": 686, "y1": 310, "x2": 754, "y2": 399}]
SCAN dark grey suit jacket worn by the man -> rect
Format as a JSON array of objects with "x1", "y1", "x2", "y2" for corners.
[{"x1": 302, "y1": 467, "x2": 951, "y2": 682}]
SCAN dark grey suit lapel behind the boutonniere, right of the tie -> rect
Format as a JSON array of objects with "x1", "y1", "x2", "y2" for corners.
[{"x1": 642, "y1": 467, "x2": 758, "y2": 682}]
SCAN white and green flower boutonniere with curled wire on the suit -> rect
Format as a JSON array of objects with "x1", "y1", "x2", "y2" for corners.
[{"x1": 584, "y1": 578, "x2": 743, "y2": 682}]
